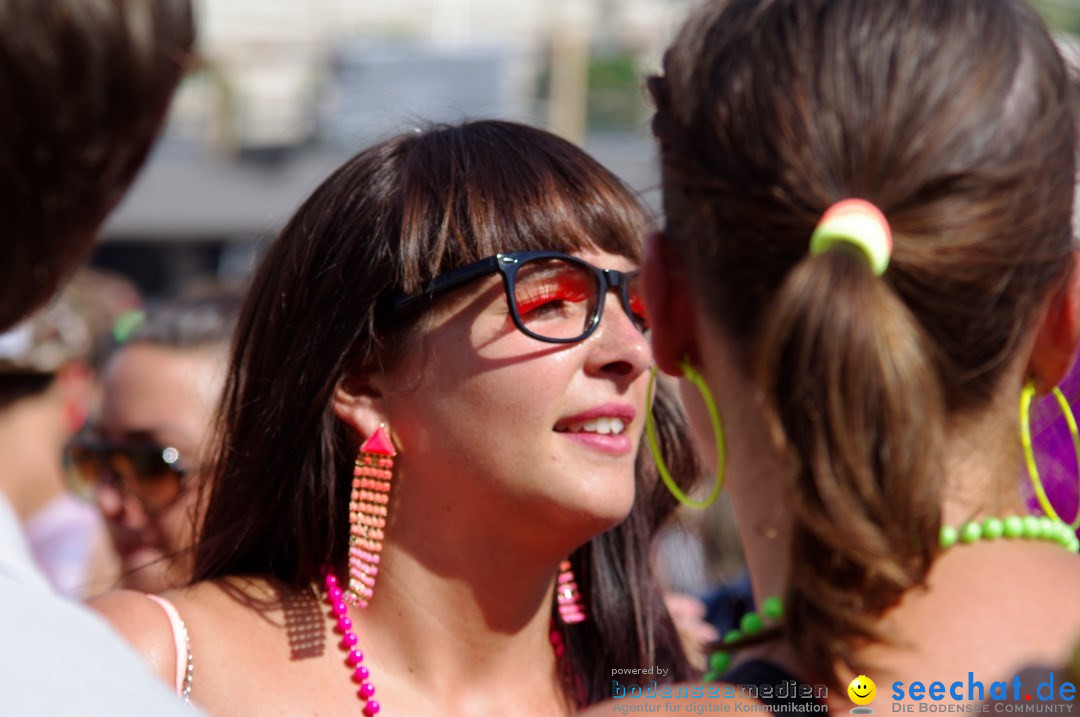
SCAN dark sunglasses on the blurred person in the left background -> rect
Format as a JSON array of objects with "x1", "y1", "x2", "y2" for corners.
[{"x1": 64, "y1": 437, "x2": 188, "y2": 513}]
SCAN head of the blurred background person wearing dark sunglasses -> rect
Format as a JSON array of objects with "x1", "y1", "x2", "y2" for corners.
[{"x1": 67, "y1": 292, "x2": 240, "y2": 593}]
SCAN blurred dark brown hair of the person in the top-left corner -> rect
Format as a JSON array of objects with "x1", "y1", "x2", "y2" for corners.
[{"x1": 0, "y1": 0, "x2": 194, "y2": 328}]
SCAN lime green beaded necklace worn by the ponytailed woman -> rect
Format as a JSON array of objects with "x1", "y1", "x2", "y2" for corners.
[{"x1": 703, "y1": 515, "x2": 1080, "y2": 682}]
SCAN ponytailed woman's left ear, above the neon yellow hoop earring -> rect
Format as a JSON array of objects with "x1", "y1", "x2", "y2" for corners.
[{"x1": 642, "y1": 232, "x2": 698, "y2": 376}]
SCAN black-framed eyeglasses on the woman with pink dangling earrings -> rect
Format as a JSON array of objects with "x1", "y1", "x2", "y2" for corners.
[{"x1": 392, "y1": 252, "x2": 648, "y2": 343}]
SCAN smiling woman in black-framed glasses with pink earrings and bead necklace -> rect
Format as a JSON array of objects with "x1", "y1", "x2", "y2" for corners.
[{"x1": 95, "y1": 121, "x2": 698, "y2": 716}]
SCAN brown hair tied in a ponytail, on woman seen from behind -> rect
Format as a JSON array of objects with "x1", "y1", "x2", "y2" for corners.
[{"x1": 650, "y1": 0, "x2": 1077, "y2": 680}]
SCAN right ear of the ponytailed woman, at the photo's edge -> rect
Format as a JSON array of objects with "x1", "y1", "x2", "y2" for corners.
[{"x1": 1027, "y1": 253, "x2": 1080, "y2": 393}]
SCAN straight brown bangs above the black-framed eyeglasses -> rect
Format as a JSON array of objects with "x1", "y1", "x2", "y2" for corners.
[{"x1": 400, "y1": 121, "x2": 651, "y2": 293}]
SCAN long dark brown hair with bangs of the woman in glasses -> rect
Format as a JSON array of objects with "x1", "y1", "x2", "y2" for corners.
[{"x1": 194, "y1": 121, "x2": 698, "y2": 702}]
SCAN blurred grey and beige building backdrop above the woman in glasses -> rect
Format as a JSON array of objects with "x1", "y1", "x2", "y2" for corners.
[{"x1": 93, "y1": 0, "x2": 688, "y2": 295}]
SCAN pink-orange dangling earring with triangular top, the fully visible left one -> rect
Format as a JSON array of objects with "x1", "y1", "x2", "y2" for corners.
[{"x1": 342, "y1": 423, "x2": 397, "y2": 608}]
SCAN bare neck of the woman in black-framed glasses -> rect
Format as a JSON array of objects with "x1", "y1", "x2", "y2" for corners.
[{"x1": 351, "y1": 540, "x2": 565, "y2": 701}]
